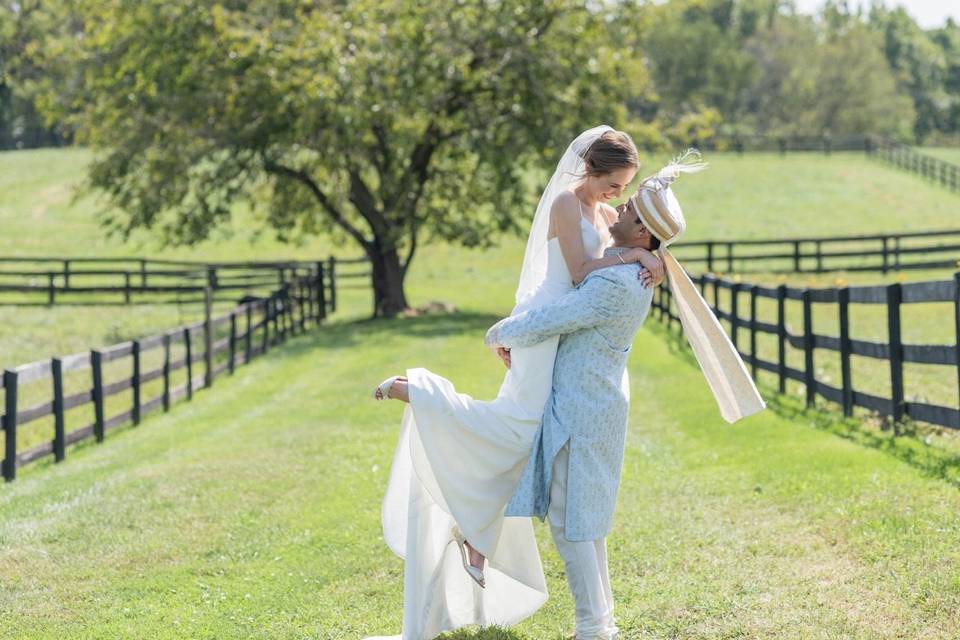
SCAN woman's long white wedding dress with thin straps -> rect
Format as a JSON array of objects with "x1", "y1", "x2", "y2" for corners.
[{"x1": 368, "y1": 217, "x2": 609, "y2": 640}]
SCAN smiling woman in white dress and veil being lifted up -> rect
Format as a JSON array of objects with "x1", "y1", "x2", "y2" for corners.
[{"x1": 368, "y1": 126, "x2": 663, "y2": 640}]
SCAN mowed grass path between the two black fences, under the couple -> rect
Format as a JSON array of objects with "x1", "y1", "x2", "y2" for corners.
[{"x1": 0, "y1": 311, "x2": 960, "y2": 640}]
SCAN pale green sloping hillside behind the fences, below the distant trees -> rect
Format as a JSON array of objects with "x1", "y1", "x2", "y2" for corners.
[{"x1": 0, "y1": 149, "x2": 960, "y2": 259}]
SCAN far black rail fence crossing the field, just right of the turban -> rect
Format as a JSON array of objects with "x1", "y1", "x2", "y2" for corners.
[{"x1": 672, "y1": 230, "x2": 960, "y2": 273}]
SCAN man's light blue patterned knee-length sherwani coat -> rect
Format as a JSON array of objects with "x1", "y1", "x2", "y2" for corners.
[{"x1": 486, "y1": 249, "x2": 653, "y2": 541}]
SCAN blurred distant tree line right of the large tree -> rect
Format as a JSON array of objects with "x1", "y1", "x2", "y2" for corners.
[{"x1": 618, "y1": 0, "x2": 960, "y2": 147}]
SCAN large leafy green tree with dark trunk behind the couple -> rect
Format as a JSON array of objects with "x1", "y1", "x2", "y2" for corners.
[{"x1": 28, "y1": 0, "x2": 645, "y2": 315}]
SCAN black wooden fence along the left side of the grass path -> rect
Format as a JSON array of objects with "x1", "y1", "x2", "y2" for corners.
[{"x1": 0, "y1": 262, "x2": 337, "y2": 482}]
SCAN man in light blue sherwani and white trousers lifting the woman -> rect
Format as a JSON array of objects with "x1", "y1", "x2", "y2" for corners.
[{"x1": 486, "y1": 198, "x2": 660, "y2": 640}]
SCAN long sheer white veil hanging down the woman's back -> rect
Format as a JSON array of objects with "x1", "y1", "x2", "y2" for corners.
[{"x1": 516, "y1": 124, "x2": 613, "y2": 304}]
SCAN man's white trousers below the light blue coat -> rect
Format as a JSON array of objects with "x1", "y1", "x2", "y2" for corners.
[{"x1": 547, "y1": 443, "x2": 617, "y2": 640}]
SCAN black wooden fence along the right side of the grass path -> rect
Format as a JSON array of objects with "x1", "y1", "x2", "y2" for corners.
[{"x1": 652, "y1": 272, "x2": 960, "y2": 429}]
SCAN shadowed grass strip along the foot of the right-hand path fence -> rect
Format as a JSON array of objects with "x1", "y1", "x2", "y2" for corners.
[{"x1": 651, "y1": 323, "x2": 960, "y2": 487}]
